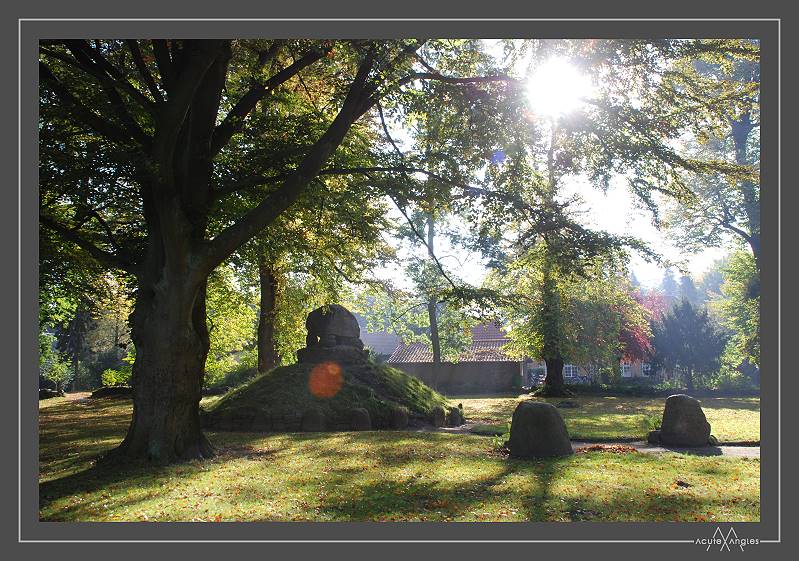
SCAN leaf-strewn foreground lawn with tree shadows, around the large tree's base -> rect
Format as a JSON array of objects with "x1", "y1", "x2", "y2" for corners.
[{"x1": 39, "y1": 398, "x2": 760, "y2": 522}]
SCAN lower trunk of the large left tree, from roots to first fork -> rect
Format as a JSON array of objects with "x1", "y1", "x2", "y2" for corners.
[{"x1": 110, "y1": 281, "x2": 213, "y2": 463}]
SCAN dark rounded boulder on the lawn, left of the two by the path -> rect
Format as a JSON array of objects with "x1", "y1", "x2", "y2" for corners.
[{"x1": 508, "y1": 401, "x2": 574, "y2": 458}]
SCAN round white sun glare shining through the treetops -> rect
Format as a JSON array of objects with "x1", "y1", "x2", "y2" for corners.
[{"x1": 527, "y1": 57, "x2": 593, "y2": 118}]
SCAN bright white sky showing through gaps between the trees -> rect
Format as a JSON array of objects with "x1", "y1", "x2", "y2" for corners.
[{"x1": 377, "y1": 41, "x2": 727, "y2": 288}]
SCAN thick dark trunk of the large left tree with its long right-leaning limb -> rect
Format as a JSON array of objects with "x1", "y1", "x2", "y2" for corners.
[{"x1": 97, "y1": 40, "x2": 375, "y2": 463}]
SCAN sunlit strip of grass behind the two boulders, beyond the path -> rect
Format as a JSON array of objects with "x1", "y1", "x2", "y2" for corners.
[{"x1": 450, "y1": 395, "x2": 760, "y2": 443}]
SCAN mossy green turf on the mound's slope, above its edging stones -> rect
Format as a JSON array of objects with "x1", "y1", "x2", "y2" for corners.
[{"x1": 203, "y1": 363, "x2": 448, "y2": 430}]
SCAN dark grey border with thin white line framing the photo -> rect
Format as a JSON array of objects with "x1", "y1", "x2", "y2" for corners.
[{"x1": 6, "y1": 1, "x2": 782, "y2": 551}]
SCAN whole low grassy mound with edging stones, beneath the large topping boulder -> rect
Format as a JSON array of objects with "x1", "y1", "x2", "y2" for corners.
[{"x1": 201, "y1": 363, "x2": 457, "y2": 431}]
